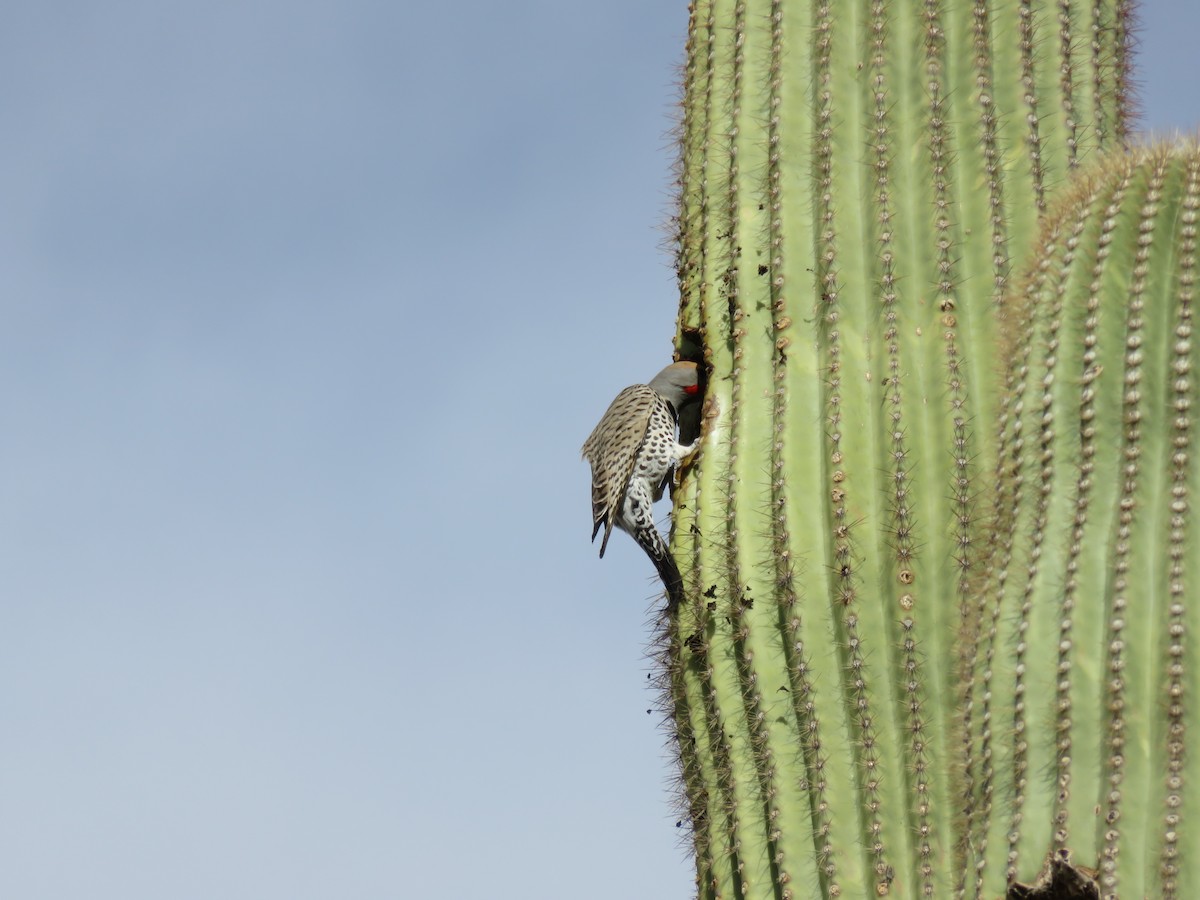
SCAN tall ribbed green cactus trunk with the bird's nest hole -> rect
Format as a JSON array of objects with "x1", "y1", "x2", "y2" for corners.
[{"x1": 660, "y1": 0, "x2": 1129, "y2": 900}]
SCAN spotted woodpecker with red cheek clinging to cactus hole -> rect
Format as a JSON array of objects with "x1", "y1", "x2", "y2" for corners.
[{"x1": 582, "y1": 360, "x2": 701, "y2": 608}]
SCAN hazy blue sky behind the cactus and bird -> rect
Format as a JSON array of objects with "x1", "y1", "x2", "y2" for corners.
[{"x1": 0, "y1": 0, "x2": 1200, "y2": 900}]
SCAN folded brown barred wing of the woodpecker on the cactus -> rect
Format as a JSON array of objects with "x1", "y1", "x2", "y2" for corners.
[{"x1": 583, "y1": 384, "x2": 662, "y2": 557}]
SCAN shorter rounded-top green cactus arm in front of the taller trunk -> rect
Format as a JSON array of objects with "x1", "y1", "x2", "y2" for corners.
[{"x1": 976, "y1": 145, "x2": 1200, "y2": 900}]
